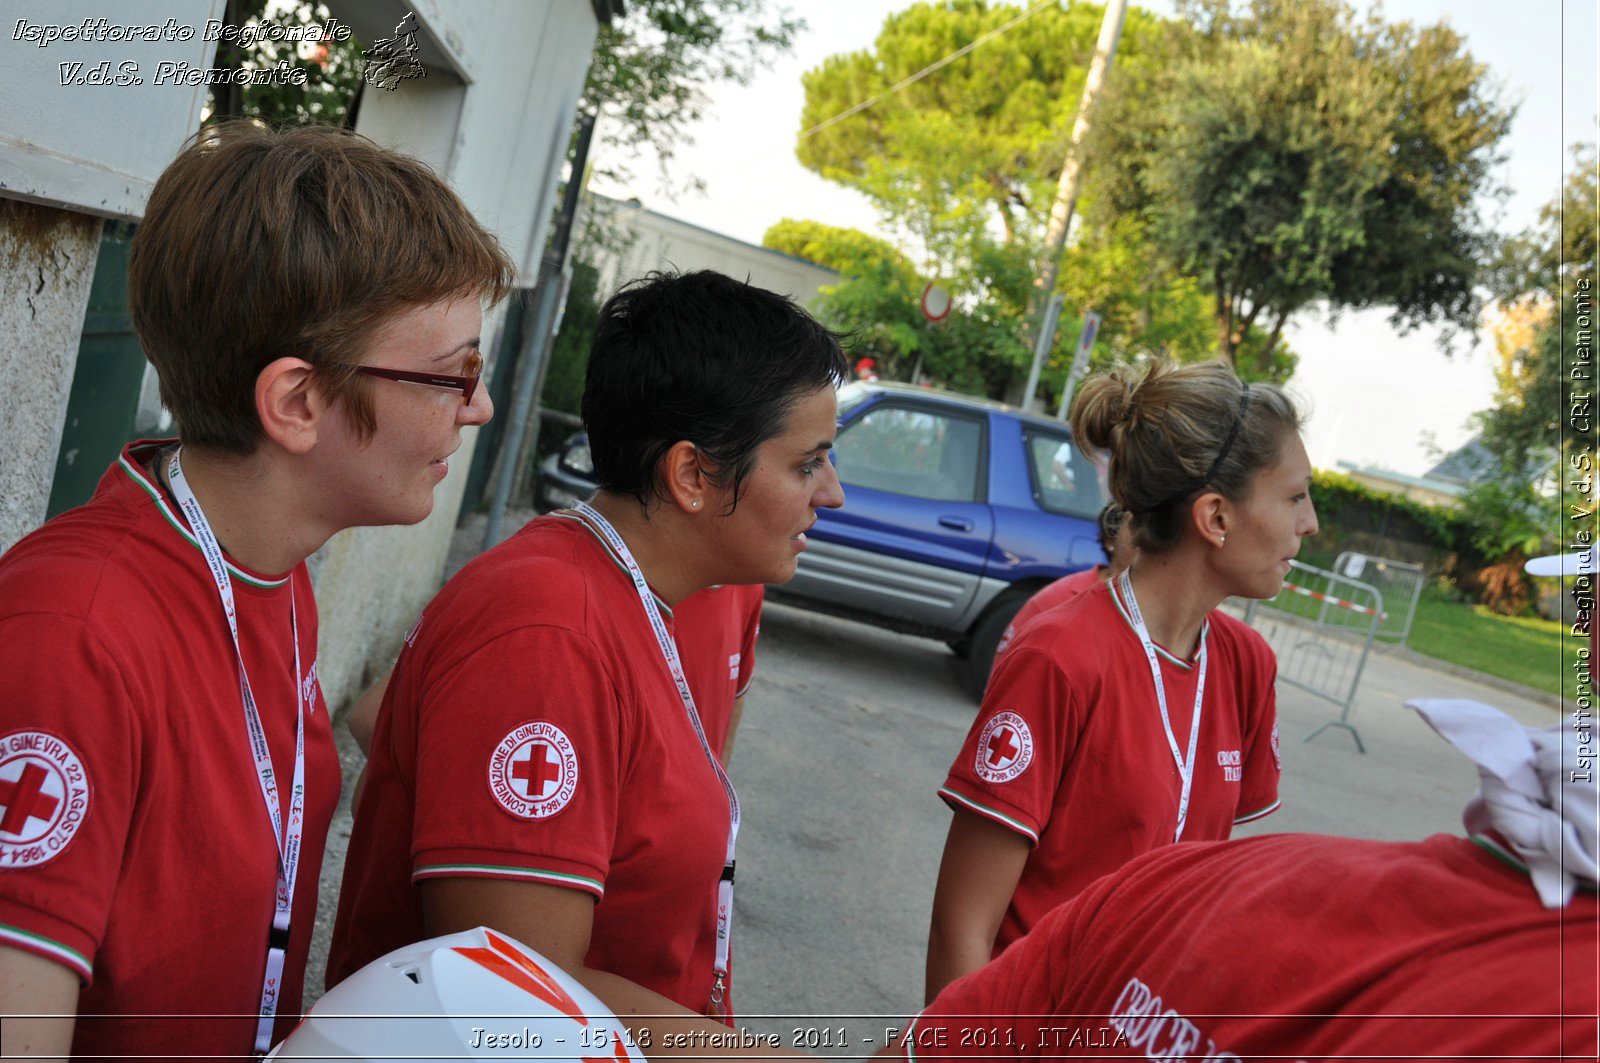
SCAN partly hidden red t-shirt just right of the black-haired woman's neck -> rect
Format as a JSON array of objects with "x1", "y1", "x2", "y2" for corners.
[{"x1": 672, "y1": 583, "x2": 766, "y2": 756}]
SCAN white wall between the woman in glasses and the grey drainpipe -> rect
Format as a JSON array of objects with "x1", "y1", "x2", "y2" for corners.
[{"x1": 312, "y1": 0, "x2": 598, "y2": 706}]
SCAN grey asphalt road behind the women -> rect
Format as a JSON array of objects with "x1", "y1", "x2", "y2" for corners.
[{"x1": 306, "y1": 592, "x2": 1557, "y2": 1053}]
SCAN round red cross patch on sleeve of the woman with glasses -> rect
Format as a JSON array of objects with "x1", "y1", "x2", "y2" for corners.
[{"x1": 0, "y1": 730, "x2": 90, "y2": 869}]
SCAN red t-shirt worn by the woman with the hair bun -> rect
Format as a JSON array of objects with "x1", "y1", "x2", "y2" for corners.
[{"x1": 939, "y1": 584, "x2": 1278, "y2": 954}]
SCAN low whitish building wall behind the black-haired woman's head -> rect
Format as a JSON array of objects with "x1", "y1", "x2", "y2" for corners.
[{"x1": 586, "y1": 195, "x2": 838, "y2": 306}]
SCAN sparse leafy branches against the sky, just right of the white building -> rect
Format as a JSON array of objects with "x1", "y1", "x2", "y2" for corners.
[{"x1": 579, "y1": 0, "x2": 805, "y2": 188}]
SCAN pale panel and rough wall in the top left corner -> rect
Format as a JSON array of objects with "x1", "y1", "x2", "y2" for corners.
[{"x1": 0, "y1": 0, "x2": 222, "y2": 551}]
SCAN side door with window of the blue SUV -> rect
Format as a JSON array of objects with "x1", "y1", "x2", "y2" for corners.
[{"x1": 784, "y1": 397, "x2": 994, "y2": 631}]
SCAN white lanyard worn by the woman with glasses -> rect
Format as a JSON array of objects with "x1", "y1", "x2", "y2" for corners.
[{"x1": 166, "y1": 447, "x2": 306, "y2": 1055}]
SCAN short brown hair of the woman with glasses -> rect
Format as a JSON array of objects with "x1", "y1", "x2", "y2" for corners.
[{"x1": 128, "y1": 122, "x2": 515, "y2": 455}]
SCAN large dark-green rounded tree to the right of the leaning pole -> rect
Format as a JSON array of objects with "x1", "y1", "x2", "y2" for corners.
[{"x1": 1090, "y1": 0, "x2": 1512, "y2": 373}]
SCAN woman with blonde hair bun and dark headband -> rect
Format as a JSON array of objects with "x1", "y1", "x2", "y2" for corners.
[{"x1": 926, "y1": 362, "x2": 1317, "y2": 1001}]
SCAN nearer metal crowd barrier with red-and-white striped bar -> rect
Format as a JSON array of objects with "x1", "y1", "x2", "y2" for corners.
[{"x1": 1245, "y1": 560, "x2": 1384, "y2": 752}]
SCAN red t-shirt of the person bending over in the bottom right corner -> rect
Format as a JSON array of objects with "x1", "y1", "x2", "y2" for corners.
[{"x1": 906, "y1": 834, "x2": 1600, "y2": 1063}]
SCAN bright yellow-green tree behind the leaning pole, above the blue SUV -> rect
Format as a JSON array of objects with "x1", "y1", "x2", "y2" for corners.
[{"x1": 797, "y1": 0, "x2": 1293, "y2": 400}]
